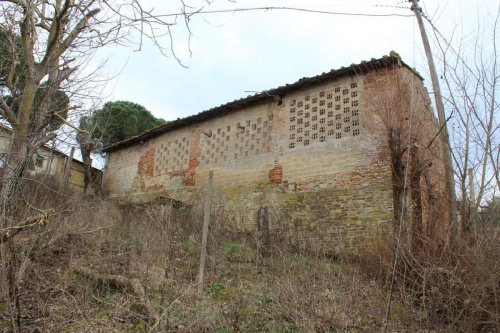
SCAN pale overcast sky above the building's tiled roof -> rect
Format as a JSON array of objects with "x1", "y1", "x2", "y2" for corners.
[{"x1": 88, "y1": 0, "x2": 499, "y2": 120}]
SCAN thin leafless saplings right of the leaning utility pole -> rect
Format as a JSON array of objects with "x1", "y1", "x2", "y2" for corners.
[{"x1": 434, "y1": 6, "x2": 500, "y2": 232}]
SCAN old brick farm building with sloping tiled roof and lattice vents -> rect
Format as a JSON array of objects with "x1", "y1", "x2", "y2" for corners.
[{"x1": 103, "y1": 57, "x2": 450, "y2": 251}]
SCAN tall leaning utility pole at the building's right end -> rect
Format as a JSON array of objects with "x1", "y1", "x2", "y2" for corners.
[{"x1": 408, "y1": 0, "x2": 458, "y2": 231}]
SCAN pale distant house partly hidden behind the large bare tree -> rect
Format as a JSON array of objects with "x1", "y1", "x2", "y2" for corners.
[{"x1": 0, "y1": 125, "x2": 97, "y2": 191}]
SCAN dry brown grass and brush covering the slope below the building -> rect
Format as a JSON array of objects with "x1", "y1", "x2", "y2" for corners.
[{"x1": 0, "y1": 178, "x2": 500, "y2": 333}]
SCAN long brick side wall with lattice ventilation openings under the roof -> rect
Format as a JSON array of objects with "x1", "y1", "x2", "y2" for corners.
[{"x1": 104, "y1": 64, "x2": 446, "y2": 252}]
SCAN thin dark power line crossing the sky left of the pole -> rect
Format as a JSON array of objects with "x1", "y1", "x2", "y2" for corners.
[{"x1": 156, "y1": 6, "x2": 413, "y2": 17}]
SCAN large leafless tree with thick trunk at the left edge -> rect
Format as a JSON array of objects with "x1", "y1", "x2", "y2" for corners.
[{"x1": 0, "y1": 0, "x2": 203, "y2": 332}]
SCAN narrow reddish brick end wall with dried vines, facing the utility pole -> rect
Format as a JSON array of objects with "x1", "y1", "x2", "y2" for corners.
[{"x1": 364, "y1": 63, "x2": 448, "y2": 237}]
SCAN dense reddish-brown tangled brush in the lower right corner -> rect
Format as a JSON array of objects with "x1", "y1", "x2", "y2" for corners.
[{"x1": 360, "y1": 225, "x2": 500, "y2": 332}]
